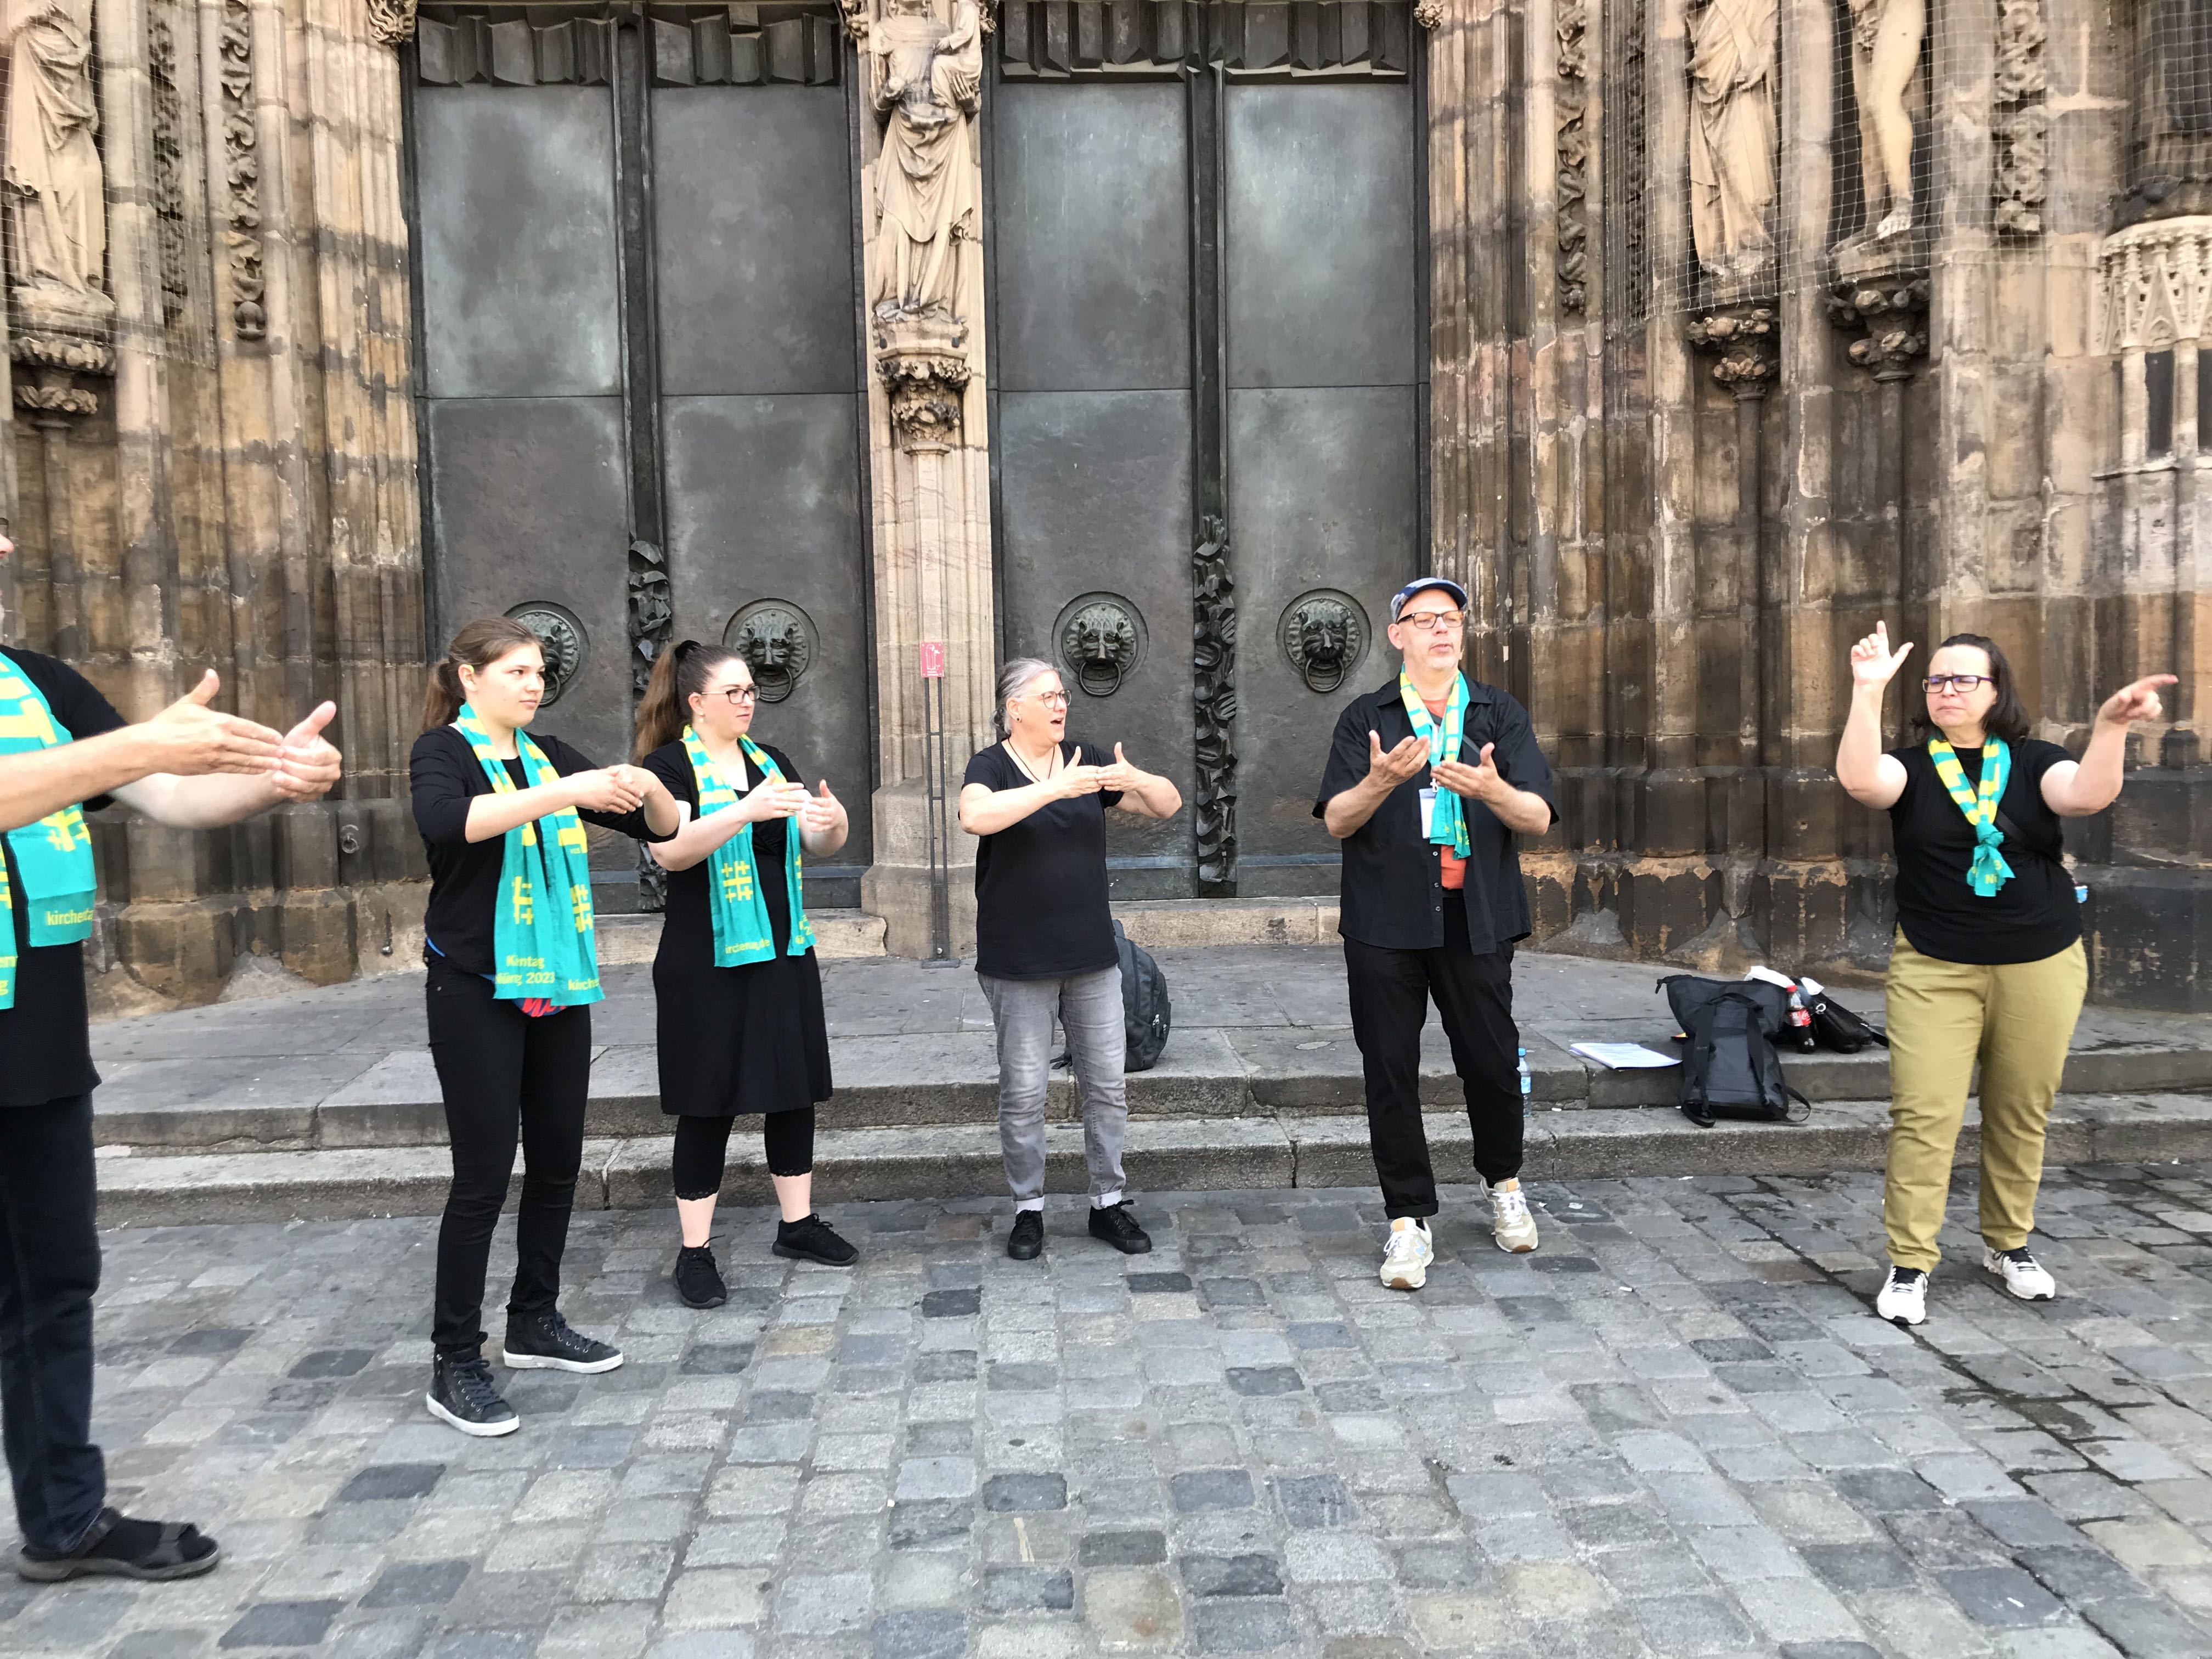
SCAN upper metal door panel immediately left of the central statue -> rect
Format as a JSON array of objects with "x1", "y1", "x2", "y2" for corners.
[{"x1": 652, "y1": 86, "x2": 860, "y2": 396}]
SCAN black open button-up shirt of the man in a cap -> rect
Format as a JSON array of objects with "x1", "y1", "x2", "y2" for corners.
[{"x1": 1314, "y1": 679, "x2": 1560, "y2": 956}]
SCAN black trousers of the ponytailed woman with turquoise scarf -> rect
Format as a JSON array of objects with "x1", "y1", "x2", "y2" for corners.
[{"x1": 425, "y1": 962, "x2": 591, "y2": 1358}]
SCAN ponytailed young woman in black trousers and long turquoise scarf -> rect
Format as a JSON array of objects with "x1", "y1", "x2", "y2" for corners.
[{"x1": 407, "y1": 617, "x2": 684, "y2": 1436}]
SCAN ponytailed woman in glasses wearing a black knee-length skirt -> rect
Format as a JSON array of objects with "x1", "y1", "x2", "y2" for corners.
[{"x1": 637, "y1": 639, "x2": 858, "y2": 1307}]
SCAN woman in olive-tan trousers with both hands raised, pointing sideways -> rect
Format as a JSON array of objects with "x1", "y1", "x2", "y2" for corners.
[{"x1": 1836, "y1": 624, "x2": 2174, "y2": 1325}]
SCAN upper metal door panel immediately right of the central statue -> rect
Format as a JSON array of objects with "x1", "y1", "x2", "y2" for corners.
[{"x1": 991, "y1": 82, "x2": 1190, "y2": 392}]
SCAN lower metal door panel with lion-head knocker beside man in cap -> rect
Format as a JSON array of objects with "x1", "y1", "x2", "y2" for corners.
[{"x1": 1228, "y1": 387, "x2": 1420, "y2": 894}]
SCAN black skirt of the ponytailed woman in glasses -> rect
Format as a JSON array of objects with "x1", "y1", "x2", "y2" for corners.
[{"x1": 652, "y1": 951, "x2": 830, "y2": 1117}]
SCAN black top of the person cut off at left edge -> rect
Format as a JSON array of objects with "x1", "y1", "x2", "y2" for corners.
[{"x1": 0, "y1": 650, "x2": 126, "y2": 1106}]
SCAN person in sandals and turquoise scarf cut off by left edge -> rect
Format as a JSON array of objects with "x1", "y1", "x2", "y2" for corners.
[{"x1": 0, "y1": 535, "x2": 338, "y2": 1582}]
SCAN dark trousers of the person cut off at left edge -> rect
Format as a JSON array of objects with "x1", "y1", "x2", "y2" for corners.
[{"x1": 0, "y1": 1095, "x2": 109, "y2": 1555}]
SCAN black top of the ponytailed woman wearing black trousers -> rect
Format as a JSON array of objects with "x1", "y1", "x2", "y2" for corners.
[{"x1": 407, "y1": 725, "x2": 668, "y2": 973}]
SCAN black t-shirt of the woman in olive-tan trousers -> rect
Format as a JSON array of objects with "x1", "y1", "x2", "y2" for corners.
[{"x1": 1889, "y1": 737, "x2": 2081, "y2": 964}]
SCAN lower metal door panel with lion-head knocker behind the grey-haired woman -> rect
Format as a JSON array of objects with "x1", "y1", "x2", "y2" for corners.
[{"x1": 993, "y1": 392, "x2": 1194, "y2": 898}]
